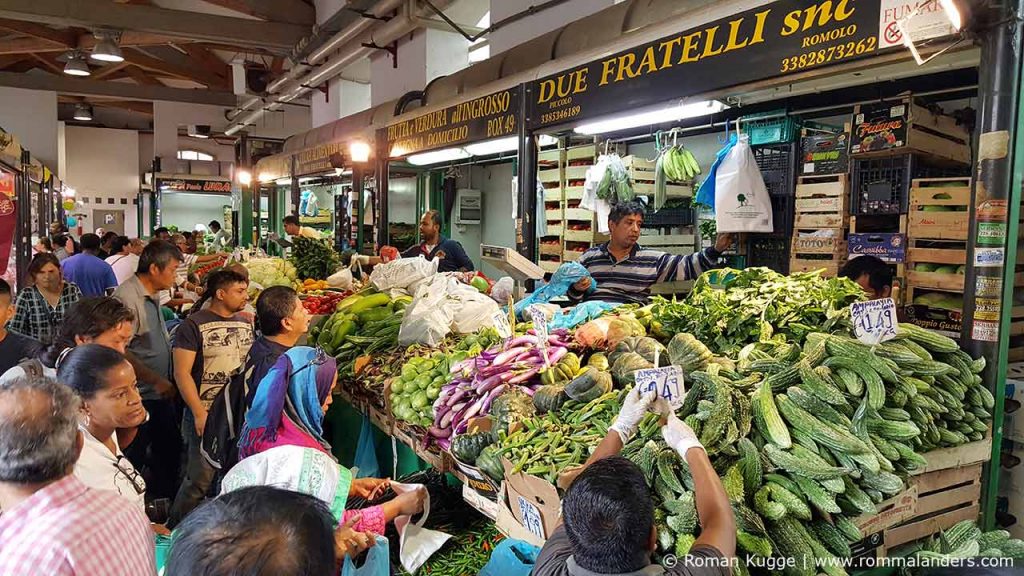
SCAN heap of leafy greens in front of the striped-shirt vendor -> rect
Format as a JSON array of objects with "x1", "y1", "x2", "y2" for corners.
[{"x1": 653, "y1": 268, "x2": 864, "y2": 356}]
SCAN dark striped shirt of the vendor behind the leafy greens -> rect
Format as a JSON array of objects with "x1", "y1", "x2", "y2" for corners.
[{"x1": 568, "y1": 243, "x2": 720, "y2": 304}]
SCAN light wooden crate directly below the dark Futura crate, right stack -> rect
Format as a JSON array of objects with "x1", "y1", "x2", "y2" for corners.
[{"x1": 907, "y1": 177, "x2": 971, "y2": 241}]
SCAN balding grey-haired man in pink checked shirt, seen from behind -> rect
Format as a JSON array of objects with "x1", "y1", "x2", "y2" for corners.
[{"x1": 0, "y1": 376, "x2": 154, "y2": 576}]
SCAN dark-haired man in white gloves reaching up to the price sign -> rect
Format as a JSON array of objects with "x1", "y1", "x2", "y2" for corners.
[{"x1": 532, "y1": 389, "x2": 736, "y2": 576}]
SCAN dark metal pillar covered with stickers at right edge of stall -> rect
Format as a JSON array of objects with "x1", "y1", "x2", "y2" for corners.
[{"x1": 963, "y1": 0, "x2": 1024, "y2": 530}]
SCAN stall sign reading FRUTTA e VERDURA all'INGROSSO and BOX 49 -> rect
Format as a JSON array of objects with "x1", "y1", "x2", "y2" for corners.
[{"x1": 387, "y1": 88, "x2": 521, "y2": 158}]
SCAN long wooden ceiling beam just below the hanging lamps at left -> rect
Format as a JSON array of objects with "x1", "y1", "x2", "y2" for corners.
[{"x1": 0, "y1": 69, "x2": 238, "y2": 108}]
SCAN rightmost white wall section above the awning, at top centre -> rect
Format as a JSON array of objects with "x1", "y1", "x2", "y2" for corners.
[{"x1": 490, "y1": 0, "x2": 617, "y2": 56}]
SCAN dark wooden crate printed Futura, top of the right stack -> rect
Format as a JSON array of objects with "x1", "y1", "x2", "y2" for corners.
[{"x1": 850, "y1": 97, "x2": 971, "y2": 164}]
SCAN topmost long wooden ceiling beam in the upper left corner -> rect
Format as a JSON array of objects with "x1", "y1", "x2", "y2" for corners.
[{"x1": 0, "y1": 0, "x2": 310, "y2": 51}]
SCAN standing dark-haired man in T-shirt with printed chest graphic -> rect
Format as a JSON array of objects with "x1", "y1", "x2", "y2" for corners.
[{"x1": 167, "y1": 270, "x2": 253, "y2": 529}]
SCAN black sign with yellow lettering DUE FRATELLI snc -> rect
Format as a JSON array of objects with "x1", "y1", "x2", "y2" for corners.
[{"x1": 526, "y1": 0, "x2": 881, "y2": 129}]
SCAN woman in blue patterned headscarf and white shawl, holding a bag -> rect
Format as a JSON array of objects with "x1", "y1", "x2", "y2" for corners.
[{"x1": 221, "y1": 346, "x2": 426, "y2": 556}]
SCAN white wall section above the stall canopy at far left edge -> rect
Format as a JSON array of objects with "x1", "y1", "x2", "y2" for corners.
[{"x1": 0, "y1": 88, "x2": 63, "y2": 174}]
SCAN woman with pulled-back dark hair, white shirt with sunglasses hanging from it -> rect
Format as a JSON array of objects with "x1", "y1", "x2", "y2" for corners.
[{"x1": 57, "y1": 344, "x2": 147, "y2": 508}]
